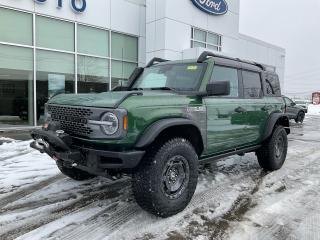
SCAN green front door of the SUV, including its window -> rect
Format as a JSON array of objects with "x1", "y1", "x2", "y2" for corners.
[{"x1": 204, "y1": 65, "x2": 246, "y2": 154}]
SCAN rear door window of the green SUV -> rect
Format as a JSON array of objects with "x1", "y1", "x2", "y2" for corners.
[{"x1": 242, "y1": 71, "x2": 262, "y2": 98}]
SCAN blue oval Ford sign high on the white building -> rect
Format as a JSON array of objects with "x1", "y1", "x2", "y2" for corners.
[{"x1": 191, "y1": 0, "x2": 228, "y2": 15}]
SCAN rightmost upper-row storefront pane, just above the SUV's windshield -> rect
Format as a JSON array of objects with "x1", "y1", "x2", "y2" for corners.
[{"x1": 111, "y1": 32, "x2": 138, "y2": 62}]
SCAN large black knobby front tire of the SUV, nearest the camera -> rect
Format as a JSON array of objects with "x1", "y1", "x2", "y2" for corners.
[{"x1": 132, "y1": 138, "x2": 198, "y2": 218}]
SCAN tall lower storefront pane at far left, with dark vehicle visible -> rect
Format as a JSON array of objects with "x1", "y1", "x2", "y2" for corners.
[{"x1": 0, "y1": 44, "x2": 34, "y2": 128}]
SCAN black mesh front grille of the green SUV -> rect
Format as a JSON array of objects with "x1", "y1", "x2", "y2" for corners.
[{"x1": 48, "y1": 105, "x2": 93, "y2": 136}]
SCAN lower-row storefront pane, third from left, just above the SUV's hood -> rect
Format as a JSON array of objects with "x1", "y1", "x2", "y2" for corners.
[{"x1": 78, "y1": 56, "x2": 109, "y2": 93}]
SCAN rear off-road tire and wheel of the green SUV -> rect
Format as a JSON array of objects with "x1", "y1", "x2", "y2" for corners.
[{"x1": 256, "y1": 126, "x2": 288, "y2": 171}]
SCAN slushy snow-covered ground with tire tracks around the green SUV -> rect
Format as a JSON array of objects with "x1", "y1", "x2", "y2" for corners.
[{"x1": 0, "y1": 115, "x2": 320, "y2": 240}]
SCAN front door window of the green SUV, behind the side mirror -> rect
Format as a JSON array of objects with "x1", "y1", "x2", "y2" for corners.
[{"x1": 211, "y1": 66, "x2": 239, "y2": 97}]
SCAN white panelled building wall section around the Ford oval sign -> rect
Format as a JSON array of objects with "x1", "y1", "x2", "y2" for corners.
[{"x1": 146, "y1": 0, "x2": 285, "y2": 85}]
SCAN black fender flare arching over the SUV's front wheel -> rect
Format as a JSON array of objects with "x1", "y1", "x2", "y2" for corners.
[{"x1": 135, "y1": 118, "x2": 201, "y2": 148}]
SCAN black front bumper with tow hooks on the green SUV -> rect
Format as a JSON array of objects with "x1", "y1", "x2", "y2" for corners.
[{"x1": 30, "y1": 130, "x2": 145, "y2": 175}]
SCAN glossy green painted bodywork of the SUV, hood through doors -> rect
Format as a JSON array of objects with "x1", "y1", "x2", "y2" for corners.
[{"x1": 48, "y1": 60, "x2": 284, "y2": 157}]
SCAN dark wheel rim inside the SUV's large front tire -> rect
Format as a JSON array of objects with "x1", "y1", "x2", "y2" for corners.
[{"x1": 162, "y1": 156, "x2": 190, "y2": 199}]
